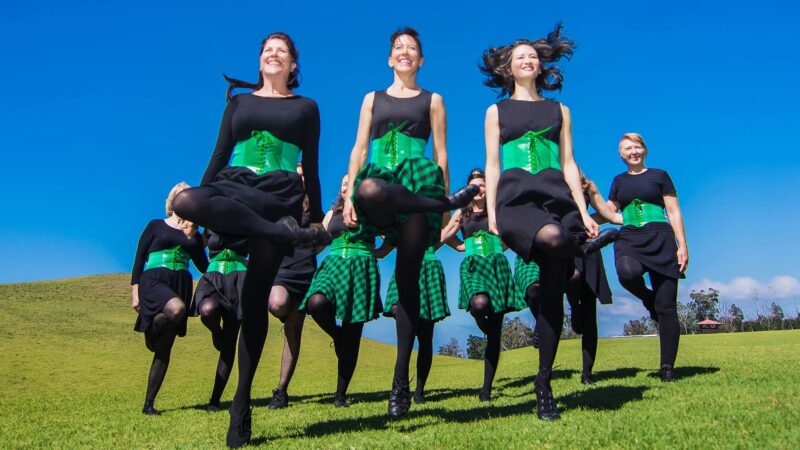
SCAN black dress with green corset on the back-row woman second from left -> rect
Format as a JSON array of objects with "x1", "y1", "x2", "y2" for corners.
[{"x1": 189, "y1": 229, "x2": 248, "y2": 320}]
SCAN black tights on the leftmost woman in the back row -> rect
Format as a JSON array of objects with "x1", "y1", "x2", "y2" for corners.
[{"x1": 145, "y1": 297, "x2": 186, "y2": 402}]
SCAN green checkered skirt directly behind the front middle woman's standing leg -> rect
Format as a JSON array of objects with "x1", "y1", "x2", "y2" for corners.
[{"x1": 383, "y1": 259, "x2": 450, "y2": 322}]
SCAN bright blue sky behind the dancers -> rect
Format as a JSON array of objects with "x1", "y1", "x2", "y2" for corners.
[{"x1": 0, "y1": 1, "x2": 800, "y2": 343}]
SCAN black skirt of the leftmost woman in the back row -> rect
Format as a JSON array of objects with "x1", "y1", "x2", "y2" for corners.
[{"x1": 133, "y1": 267, "x2": 192, "y2": 336}]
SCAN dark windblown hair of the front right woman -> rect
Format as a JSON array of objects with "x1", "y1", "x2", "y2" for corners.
[{"x1": 478, "y1": 22, "x2": 576, "y2": 97}]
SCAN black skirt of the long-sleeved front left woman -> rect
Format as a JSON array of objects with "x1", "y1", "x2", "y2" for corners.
[{"x1": 208, "y1": 166, "x2": 304, "y2": 225}]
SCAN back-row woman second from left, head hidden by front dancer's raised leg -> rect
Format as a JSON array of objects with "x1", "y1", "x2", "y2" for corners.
[{"x1": 189, "y1": 229, "x2": 247, "y2": 412}]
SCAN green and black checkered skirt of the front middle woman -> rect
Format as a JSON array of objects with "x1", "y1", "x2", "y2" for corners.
[{"x1": 353, "y1": 158, "x2": 445, "y2": 245}]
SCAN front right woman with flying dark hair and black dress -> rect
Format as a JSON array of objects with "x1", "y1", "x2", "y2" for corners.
[{"x1": 481, "y1": 24, "x2": 607, "y2": 420}]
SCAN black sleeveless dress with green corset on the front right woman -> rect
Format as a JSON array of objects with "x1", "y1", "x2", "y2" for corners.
[{"x1": 496, "y1": 99, "x2": 585, "y2": 265}]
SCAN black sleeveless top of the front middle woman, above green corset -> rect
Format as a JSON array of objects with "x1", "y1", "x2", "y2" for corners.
[{"x1": 370, "y1": 89, "x2": 433, "y2": 142}]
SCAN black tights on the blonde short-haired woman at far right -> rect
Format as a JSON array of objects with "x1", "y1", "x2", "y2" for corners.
[{"x1": 616, "y1": 256, "x2": 680, "y2": 366}]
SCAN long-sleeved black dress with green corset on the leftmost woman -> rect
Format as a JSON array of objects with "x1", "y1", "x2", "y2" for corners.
[{"x1": 131, "y1": 219, "x2": 208, "y2": 336}]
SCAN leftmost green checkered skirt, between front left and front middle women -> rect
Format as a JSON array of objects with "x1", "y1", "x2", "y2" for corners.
[{"x1": 300, "y1": 255, "x2": 383, "y2": 323}]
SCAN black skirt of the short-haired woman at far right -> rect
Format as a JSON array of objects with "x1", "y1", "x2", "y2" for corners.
[{"x1": 614, "y1": 223, "x2": 683, "y2": 279}]
